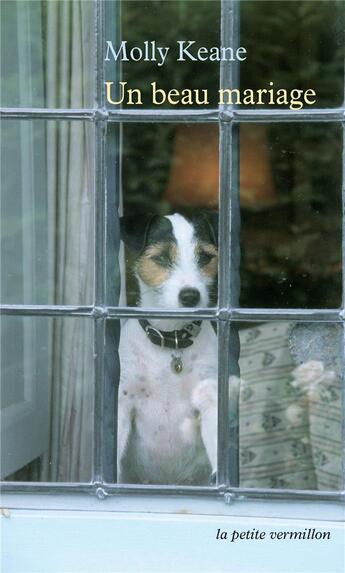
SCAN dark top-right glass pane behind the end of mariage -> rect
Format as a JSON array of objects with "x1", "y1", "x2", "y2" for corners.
[{"x1": 240, "y1": 0, "x2": 345, "y2": 109}]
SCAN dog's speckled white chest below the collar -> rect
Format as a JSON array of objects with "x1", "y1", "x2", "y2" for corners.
[{"x1": 120, "y1": 323, "x2": 216, "y2": 442}]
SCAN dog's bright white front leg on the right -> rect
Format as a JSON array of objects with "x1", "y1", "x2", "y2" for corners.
[{"x1": 192, "y1": 378, "x2": 217, "y2": 475}]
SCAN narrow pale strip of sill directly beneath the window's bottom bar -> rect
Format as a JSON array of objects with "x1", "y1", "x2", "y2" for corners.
[{"x1": 1, "y1": 493, "x2": 345, "y2": 521}]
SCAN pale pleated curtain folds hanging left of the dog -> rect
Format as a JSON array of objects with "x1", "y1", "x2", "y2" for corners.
[{"x1": 42, "y1": 0, "x2": 94, "y2": 481}]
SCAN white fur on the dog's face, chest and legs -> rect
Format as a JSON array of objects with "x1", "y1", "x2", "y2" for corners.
[{"x1": 118, "y1": 215, "x2": 217, "y2": 485}]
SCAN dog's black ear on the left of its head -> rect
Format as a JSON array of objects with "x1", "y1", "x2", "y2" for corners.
[{"x1": 120, "y1": 213, "x2": 156, "y2": 254}]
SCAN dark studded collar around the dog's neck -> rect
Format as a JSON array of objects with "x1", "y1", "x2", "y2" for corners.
[{"x1": 139, "y1": 319, "x2": 201, "y2": 350}]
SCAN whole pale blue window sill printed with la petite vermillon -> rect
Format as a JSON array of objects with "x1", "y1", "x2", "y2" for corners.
[{"x1": 1, "y1": 494, "x2": 344, "y2": 573}]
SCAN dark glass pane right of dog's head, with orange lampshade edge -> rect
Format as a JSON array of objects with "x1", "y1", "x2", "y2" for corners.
[{"x1": 240, "y1": 123, "x2": 342, "y2": 308}]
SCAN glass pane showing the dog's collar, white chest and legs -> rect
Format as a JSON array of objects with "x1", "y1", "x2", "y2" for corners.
[{"x1": 118, "y1": 319, "x2": 218, "y2": 486}]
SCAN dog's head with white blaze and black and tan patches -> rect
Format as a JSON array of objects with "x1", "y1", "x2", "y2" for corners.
[{"x1": 121, "y1": 212, "x2": 218, "y2": 307}]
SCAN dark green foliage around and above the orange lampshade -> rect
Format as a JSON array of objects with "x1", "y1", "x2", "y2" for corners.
[{"x1": 122, "y1": 0, "x2": 345, "y2": 308}]
